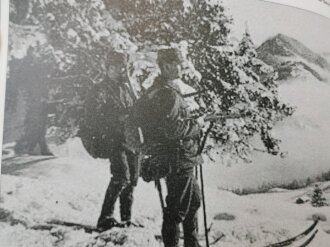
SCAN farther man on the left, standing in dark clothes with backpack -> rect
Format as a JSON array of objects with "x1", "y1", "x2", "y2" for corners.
[{"x1": 87, "y1": 52, "x2": 139, "y2": 231}]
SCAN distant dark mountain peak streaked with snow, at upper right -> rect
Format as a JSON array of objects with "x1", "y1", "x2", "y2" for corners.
[{"x1": 257, "y1": 34, "x2": 330, "y2": 81}]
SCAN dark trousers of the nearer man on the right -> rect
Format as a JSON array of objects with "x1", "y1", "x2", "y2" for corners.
[{"x1": 162, "y1": 172, "x2": 201, "y2": 247}]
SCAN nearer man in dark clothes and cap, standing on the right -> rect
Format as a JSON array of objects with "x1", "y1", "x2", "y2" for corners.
[{"x1": 137, "y1": 48, "x2": 202, "y2": 247}]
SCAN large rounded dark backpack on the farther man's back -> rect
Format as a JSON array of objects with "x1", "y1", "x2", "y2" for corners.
[{"x1": 79, "y1": 80, "x2": 133, "y2": 159}]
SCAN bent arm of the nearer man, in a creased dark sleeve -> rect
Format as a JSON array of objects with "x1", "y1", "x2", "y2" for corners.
[{"x1": 158, "y1": 90, "x2": 201, "y2": 139}]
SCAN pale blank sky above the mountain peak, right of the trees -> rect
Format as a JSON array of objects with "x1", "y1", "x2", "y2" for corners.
[{"x1": 223, "y1": 0, "x2": 330, "y2": 52}]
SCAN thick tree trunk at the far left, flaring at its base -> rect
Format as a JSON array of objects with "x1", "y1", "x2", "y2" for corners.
[{"x1": 6, "y1": 52, "x2": 51, "y2": 155}]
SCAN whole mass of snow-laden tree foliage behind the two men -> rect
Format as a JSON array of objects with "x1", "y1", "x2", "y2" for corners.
[{"x1": 6, "y1": 0, "x2": 292, "y2": 160}]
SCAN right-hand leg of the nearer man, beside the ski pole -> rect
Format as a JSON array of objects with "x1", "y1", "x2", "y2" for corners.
[{"x1": 183, "y1": 178, "x2": 201, "y2": 247}]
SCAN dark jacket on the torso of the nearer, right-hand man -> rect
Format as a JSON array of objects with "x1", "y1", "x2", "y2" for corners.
[{"x1": 133, "y1": 77, "x2": 202, "y2": 175}]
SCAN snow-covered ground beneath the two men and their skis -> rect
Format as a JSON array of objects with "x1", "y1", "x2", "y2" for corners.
[{"x1": 0, "y1": 137, "x2": 330, "y2": 247}]
